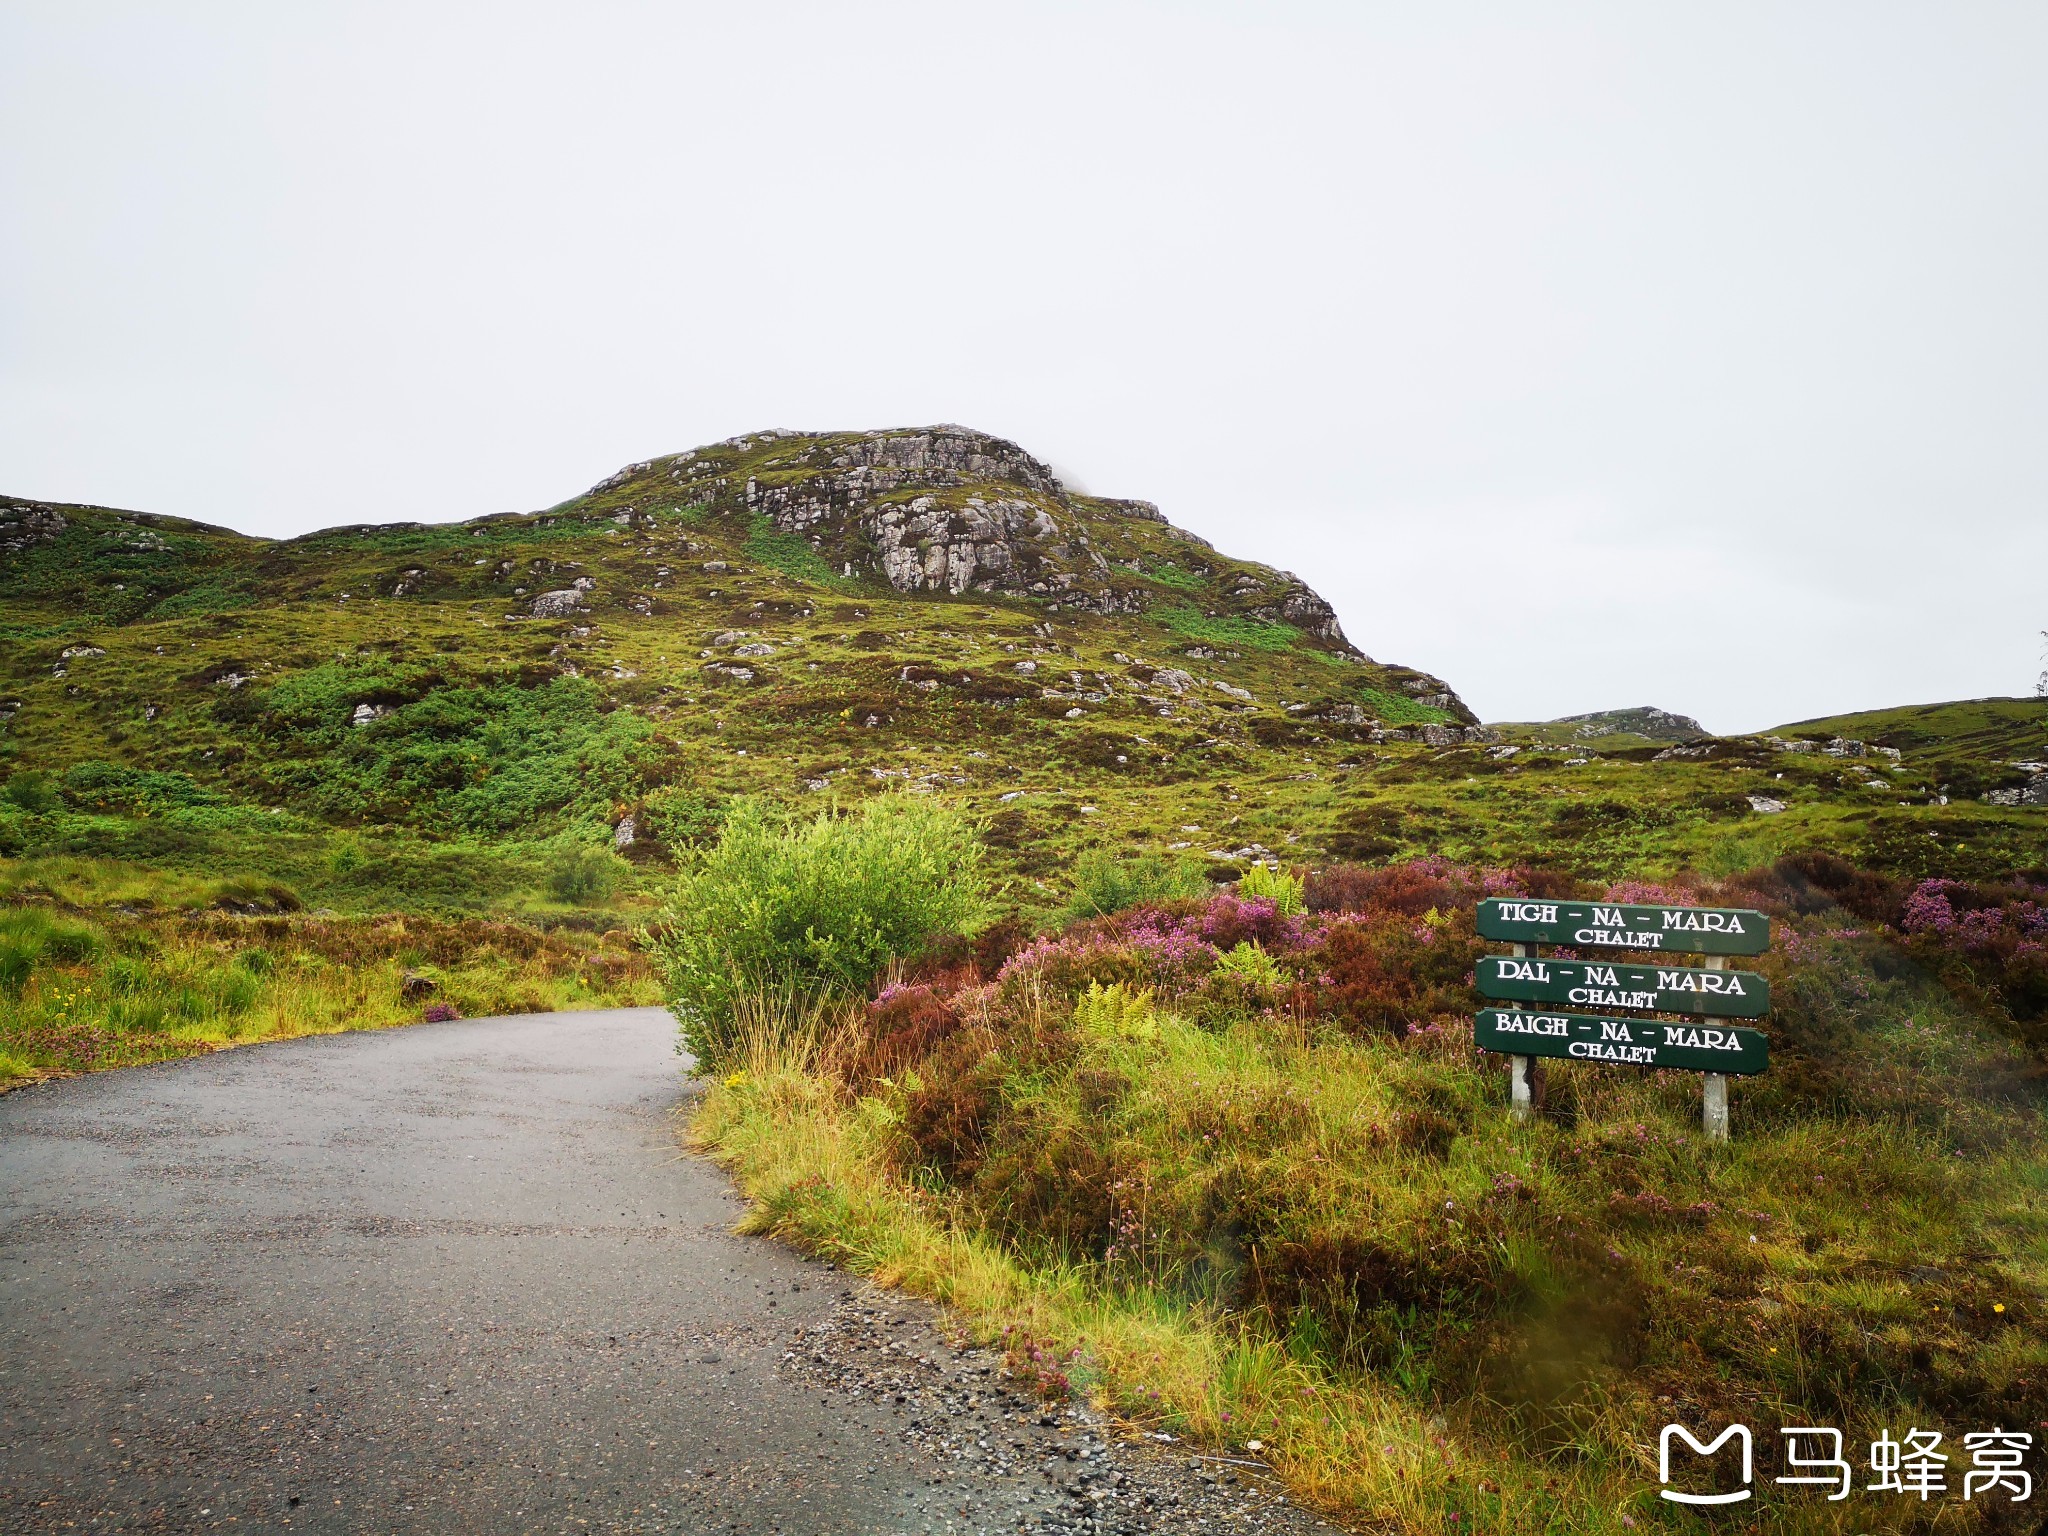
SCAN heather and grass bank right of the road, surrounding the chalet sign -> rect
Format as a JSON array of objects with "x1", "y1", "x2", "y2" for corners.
[{"x1": 698, "y1": 858, "x2": 2048, "y2": 1532}]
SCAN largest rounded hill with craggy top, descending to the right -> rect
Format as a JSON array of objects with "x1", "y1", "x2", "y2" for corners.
[{"x1": 0, "y1": 426, "x2": 1475, "y2": 905}]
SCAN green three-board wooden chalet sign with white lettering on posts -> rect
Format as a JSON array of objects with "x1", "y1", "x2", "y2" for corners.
[{"x1": 1473, "y1": 897, "x2": 1772, "y2": 1141}]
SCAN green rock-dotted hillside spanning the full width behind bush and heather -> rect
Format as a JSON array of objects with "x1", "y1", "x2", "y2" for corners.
[{"x1": 0, "y1": 428, "x2": 2044, "y2": 1065}]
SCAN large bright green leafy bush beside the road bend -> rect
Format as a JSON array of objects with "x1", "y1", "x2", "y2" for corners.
[{"x1": 651, "y1": 799, "x2": 981, "y2": 1065}]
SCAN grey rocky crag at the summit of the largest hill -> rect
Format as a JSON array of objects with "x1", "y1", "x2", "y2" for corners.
[{"x1": 622, "y1": 426, "x2": 1348, "y2": 645}]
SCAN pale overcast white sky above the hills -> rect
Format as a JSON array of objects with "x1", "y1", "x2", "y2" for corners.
[{"x1": 0, "y1": 0, "x2": 2048, "y2": 731}]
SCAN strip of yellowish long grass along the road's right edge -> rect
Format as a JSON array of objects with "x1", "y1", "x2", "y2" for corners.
[{"x1": 690, "y1": 1028, "x2": 1636, "y2": 1530}]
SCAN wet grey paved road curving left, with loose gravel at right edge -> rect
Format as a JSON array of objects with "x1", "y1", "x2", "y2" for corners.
[{"x1": 0, "y1": 1008, "x2": 1329, "y2": 1536}]
